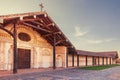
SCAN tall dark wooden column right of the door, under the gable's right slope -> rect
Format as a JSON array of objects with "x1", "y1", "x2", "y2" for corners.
[{"x1": 52, "y1": 34, "x2": 56, "y2": 69}]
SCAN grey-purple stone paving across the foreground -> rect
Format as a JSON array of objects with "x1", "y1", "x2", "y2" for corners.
[{"x1": 0, "y1": 66, "x2": 120, "y2": 80}]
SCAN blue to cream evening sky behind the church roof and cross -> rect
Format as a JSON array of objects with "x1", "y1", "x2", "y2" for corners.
[{"x1": 0, "y1": 0, "x2": 120, "y2": 54}]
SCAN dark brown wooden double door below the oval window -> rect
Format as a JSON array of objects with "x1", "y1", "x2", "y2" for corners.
[{"x1": 18, "y1": 49, "x2": 30, "y2": 69}]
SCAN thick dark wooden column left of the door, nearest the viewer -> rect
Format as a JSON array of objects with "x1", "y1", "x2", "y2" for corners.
[{"x1": 13, "y1": 22, "x2": 18, "y2": 74}]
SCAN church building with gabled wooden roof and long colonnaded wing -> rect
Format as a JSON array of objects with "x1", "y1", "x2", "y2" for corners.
[{"x1": 0, "y1": 11, "x2": 117, "y2": 73}]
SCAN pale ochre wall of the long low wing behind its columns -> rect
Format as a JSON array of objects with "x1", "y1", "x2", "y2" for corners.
[{"x1": 68, "y1": 55, "x2": 115, "y2": 67}]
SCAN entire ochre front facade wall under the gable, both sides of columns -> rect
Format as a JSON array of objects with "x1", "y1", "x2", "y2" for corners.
[{"x1": 0, "y1": 24, "x2": 66, "y2": 70}]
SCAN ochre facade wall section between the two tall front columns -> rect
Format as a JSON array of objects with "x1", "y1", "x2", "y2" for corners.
[{"x1": 17, "y1": 25, "x2": 53, "y2": 68}]
